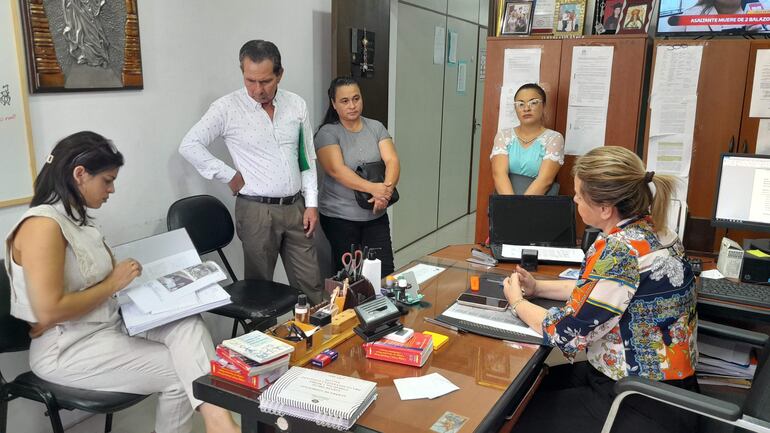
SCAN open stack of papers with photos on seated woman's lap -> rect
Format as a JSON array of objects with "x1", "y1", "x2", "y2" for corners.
[{"x1": 113, "y1": 229, "x2": 230, "y2": 335}]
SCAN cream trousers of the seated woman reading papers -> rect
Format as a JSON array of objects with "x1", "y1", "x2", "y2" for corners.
[{"x1": 30, "y1": 315, "x2": 215, "y2": 433}]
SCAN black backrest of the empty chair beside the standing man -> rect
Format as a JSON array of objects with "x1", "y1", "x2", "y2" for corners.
[{"x1": 166, "y1": 195, "x2": 235, "y2": 255}]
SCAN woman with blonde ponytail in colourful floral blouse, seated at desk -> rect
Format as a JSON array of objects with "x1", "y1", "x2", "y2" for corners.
[{"x1": 505, "y1": 146, "x2": 697, "y2": 433}]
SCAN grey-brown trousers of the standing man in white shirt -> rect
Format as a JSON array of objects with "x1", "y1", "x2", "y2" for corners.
[{"x1": 235, "y1": 197, "x2": 323, "y2": 303}]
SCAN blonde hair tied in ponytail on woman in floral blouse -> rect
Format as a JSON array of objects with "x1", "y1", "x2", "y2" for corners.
[{"x1": 572, "y1": 146, "x2": 676, "y2": 233}]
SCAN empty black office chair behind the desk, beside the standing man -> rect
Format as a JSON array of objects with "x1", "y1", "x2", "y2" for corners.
[{"x1": 166, "y1": 195, "x2": 300, "y2": 337}]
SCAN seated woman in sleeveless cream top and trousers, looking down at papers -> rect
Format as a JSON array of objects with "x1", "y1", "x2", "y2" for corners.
[{"x1": 5, "y1": 132, "x2": 241, "y2": 433}]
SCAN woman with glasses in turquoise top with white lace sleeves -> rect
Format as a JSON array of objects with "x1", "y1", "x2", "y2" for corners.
[{"x1": 489, "y1": 83, "x2": 564, "y2": 195}]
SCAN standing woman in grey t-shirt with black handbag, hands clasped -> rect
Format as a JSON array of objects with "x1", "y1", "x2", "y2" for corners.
[{"x1": 315, "y1": 77, "x2": 400, "y2": 276}]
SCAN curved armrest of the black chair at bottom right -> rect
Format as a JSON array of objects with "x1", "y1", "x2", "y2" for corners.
[{"x1": 615, "y1": 377, "x2": 742, "y2": 421}]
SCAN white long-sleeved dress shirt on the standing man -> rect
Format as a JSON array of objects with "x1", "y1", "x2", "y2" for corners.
[{"x1": 179, "y1": 87, "x2": 318, "y2": 207}]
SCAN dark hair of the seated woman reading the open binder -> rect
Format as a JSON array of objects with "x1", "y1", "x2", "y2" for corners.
[{"x1": 30, "y1": 131, "x2": 123, "y2": 226}]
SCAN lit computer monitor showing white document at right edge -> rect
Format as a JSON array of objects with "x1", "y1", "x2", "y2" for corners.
[{"x1": 711, "y1": 153, "x2": 770, "y2": 232}]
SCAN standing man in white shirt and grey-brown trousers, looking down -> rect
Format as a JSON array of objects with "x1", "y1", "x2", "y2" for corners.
[{"x1": 179, "y1": 40, "x2": 322, "y2": 302}]
